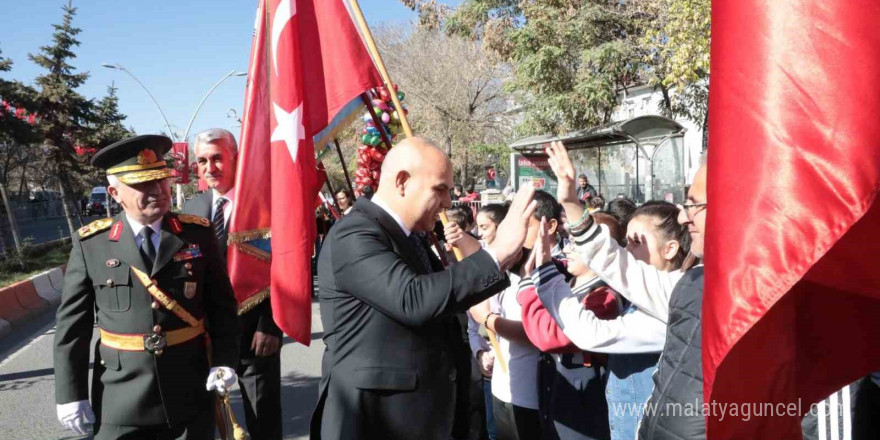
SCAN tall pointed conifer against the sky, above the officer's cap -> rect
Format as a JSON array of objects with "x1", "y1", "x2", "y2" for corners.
[{"x1": 28, "y1": 1, "x2": 94, "y2": 235}]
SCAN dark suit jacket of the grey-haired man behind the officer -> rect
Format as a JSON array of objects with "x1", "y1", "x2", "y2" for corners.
[{"x1": 183, "y1": 190, "x2": 282, "y2": 359}]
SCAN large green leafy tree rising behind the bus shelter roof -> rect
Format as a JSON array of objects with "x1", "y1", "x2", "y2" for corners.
[{"x1": 446, "y1": 0, "x2": 650, "y2": 133}]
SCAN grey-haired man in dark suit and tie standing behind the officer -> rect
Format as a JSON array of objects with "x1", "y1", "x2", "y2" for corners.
[{"x1": 183, "y1": 128, "x2": 282, "y2": 440}]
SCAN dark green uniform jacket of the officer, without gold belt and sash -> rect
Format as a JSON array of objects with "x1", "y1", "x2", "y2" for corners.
[{"x1": 55, "y1": 213, "x2": 239, "y2": 426}]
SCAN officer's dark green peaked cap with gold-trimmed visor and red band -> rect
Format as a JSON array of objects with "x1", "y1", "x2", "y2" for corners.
[{"x1": 92, "y1": 134, "x2": 171, "y2": 185}]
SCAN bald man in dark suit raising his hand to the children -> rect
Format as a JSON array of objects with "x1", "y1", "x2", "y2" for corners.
[{"x1": 311, "y1": 138, "x2": 534, "y2": 440}]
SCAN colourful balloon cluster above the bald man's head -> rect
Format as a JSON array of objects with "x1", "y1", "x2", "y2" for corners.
[{"x1": 354, "y1": 85, "x2": 409, "y2": 194}]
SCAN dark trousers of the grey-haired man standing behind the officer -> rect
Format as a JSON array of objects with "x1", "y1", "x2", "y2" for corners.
[{"x1": 236, "y1": 349, "x2": 281, "y2": 440}]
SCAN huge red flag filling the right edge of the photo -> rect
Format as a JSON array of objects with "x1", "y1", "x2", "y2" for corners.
[{"x1": 702, "y1": 0, "x2": 880, "y2": 440}]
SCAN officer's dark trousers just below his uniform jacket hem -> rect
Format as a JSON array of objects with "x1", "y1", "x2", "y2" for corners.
[{"x1": 95, "y1": 404, "x2": 216, "y2": 440}]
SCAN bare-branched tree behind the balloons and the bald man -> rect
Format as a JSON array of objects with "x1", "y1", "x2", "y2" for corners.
[{"x1": 375, "y1": 26, "x2": 515, "y2": 182}]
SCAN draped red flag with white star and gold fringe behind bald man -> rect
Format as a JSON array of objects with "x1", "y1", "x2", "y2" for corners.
[{"x1": 227, "y1": 0, "x2": 382, "y2": 345}]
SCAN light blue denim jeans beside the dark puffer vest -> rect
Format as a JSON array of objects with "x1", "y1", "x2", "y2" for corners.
[{"x1": 605, "y1": 353, "x2": 660, "y2": 440}]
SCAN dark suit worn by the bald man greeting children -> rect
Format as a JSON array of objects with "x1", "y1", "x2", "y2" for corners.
[{"x1": 311, "y1": 199, "x2": 510, "y2": 440}]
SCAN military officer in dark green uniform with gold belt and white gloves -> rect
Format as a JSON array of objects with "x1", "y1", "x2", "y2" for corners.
[{"x1": 55, "y1": 135, "x2": 239, "y2": 440}]
